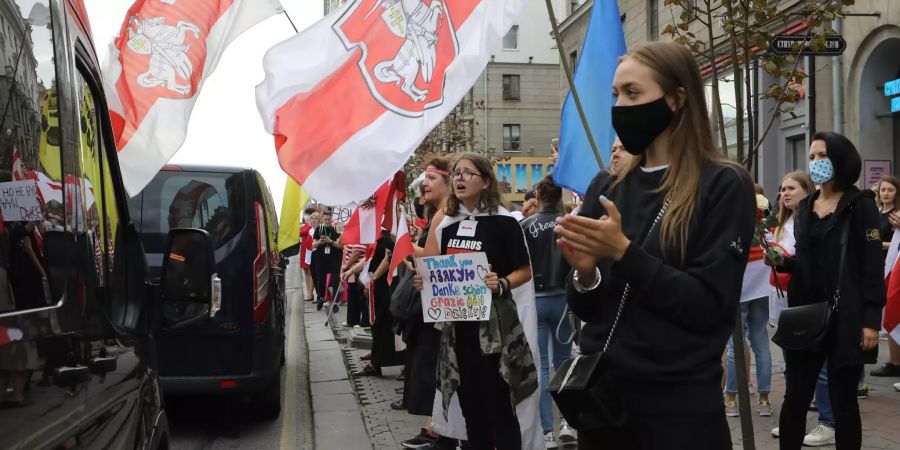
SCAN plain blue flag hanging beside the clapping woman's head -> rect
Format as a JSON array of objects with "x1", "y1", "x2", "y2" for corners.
[{"x1": 553, "y1": 0, "x2": 625, "y2": 195}]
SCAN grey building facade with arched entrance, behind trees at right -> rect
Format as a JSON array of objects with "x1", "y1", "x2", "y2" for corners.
[{"x1": 559, "y1": 0, "x2": 900, "y2": 197}]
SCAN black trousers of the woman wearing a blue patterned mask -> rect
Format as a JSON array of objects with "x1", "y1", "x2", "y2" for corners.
[{"x1": 778, "y1": 350, "x2": 862, "y2": 450}]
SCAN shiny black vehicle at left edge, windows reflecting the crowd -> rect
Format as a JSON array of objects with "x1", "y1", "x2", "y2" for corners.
[{"x1": 0, "y1": 0, "x2": 168, "y2": 449}]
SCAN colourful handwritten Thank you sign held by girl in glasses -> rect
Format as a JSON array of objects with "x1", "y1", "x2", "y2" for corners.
[{"x1": 416, "y1": 253, "x2": 491, "y2": 322}]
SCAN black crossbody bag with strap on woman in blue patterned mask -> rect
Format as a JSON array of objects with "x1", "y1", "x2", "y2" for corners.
[{"x1": 772, "y1": 213, "x2": 850, "y2": 353}]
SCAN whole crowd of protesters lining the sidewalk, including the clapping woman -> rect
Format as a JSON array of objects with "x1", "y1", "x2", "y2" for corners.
[{"x1": 280, "y1": 43, "x2": 900, "y2": 449}]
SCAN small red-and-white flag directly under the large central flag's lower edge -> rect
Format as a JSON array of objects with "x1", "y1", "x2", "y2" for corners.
[{"x1": 341, "y1": 172, "x2": 405, "y2": 244}]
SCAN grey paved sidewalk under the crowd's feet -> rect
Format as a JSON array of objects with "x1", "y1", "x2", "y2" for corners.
[{"x1": 306, "y1": 296, "x2": 900, "y2": 450}]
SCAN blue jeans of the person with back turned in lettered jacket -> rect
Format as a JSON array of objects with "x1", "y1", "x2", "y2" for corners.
[{"x1": 537, "y1": 294, "x2": 572, "y2": 434}]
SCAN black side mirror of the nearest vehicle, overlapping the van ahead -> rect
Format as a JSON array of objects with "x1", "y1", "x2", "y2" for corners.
[{"x1": 160, "y1": 228, "x2": 222, "y2": 317}]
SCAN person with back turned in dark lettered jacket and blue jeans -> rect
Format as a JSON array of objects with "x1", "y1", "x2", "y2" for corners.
[{"x1": 519, "y1": 175, "x2": 575, "y2": 448}]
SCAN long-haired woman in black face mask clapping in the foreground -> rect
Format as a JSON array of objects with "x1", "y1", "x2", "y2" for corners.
[{"x1": 556, "y1": 42, "x2": 756, "y2": 450}]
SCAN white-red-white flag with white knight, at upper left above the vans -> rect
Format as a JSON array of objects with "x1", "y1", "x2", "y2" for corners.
[{"x1": 103, "y1": 0, "x2": 282, "y2": 195}]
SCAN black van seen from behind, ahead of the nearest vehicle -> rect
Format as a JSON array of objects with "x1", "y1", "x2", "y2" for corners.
[{"x1": 129, "y1": 166, "x2": 285, "y2": 418}]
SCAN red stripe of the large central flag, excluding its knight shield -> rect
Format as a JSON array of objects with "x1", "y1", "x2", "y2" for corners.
[{"x1": 273, "y1": 0, "x2": 482, "y2": 184}]
